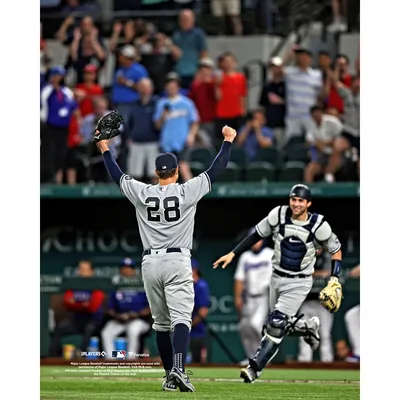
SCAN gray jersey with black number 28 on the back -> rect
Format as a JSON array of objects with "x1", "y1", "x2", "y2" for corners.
[{"x1": 120, "y1": 172, "x2": 211, "y2": 250}]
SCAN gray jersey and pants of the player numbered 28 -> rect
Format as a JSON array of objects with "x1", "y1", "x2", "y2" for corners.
[{"x1": 120, "y1": 172, "x2": 211, "y2": 331}]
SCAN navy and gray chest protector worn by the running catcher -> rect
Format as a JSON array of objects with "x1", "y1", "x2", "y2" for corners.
[{"x1": 274, "y1": 206, "x2": 324, "y2": 272}]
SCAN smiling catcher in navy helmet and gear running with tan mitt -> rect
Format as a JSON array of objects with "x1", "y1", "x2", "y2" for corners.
[{"x1": 214, "y1": 184, "x2": 342, "y2": 383}]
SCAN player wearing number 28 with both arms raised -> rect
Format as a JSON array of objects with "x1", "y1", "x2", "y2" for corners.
[{"x1": 94, "y1": 111, "x2": 236, "y2": 392}]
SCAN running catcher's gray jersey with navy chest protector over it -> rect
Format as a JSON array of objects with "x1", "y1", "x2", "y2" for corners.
[{"x1": 256, "y1": 206, "x2": 341, "y2": 275}]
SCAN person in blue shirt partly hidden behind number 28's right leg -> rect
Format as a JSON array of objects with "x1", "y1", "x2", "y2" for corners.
[{"x1": 190, "y1": 258, "x2": 210, "y2": 363}]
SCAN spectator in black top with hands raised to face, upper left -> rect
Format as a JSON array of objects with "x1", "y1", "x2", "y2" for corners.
[{"x1": 66, "y1": 16, "x2": 107, "y2": 83}]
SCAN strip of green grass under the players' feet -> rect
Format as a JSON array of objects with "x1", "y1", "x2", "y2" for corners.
[{"x1": 40, "y1": 367, "x2": 360, "y2": 400}]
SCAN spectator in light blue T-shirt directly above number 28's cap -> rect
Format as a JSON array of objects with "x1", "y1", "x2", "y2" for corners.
[{"x1": 153, "y1": 72, "x2": 199, "y2": 182}]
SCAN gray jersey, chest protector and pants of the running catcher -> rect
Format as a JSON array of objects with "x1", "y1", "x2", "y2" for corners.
[{"x1": 256, "y1": 206, "x2": 341, "y2": 317}]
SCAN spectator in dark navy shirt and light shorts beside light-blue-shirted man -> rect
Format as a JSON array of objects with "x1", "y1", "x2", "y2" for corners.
[{"x1": 127, "y1": 78, "x2": 160, "y2": 183}]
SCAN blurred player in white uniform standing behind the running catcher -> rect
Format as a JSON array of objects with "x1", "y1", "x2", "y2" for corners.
[{"x1": 234, "y1": 240, "x2": 274, "y2": 365}]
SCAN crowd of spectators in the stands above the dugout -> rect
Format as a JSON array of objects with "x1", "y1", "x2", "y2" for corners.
[{"x1": 40, "y1": 0, "x2": 360, "y2": 185}]
